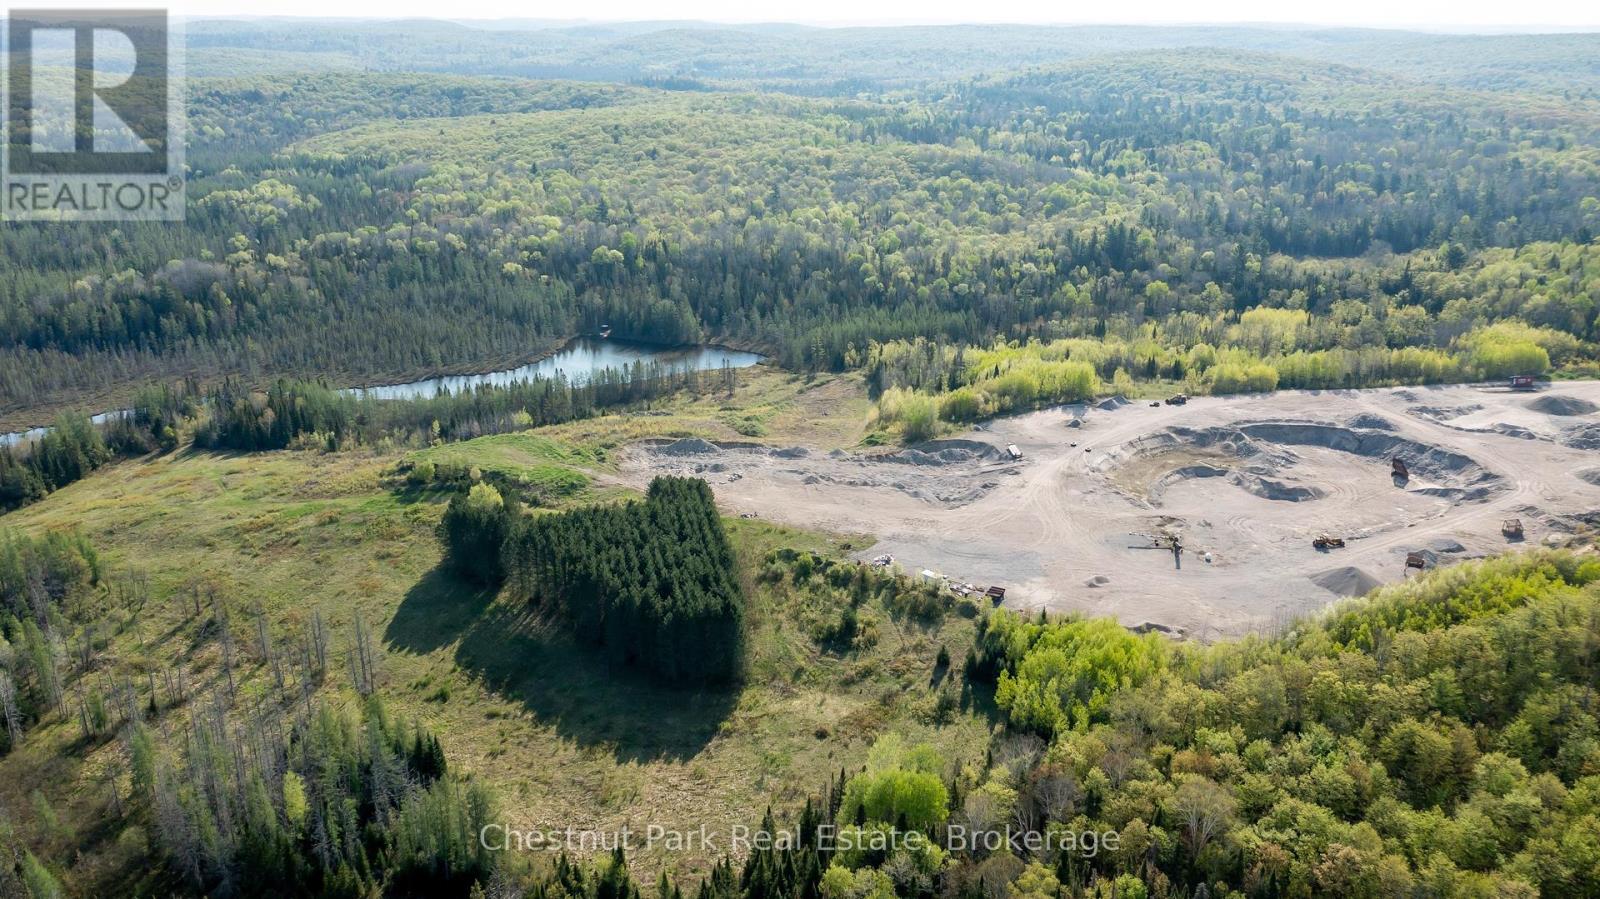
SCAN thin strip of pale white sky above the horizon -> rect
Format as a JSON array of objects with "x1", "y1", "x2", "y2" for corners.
[{"x1": 65, "y1": 0, "x2": 1600, "y2": 30}]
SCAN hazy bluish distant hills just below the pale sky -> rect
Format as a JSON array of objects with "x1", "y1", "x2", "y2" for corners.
[{"x1": 178, "y1": 19, "x2": 1600, "y2": 99}]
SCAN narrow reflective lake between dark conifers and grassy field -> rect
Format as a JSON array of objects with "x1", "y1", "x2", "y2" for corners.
[{"x1": 0, "y1": 338, "x2": 766, "y2": 446}]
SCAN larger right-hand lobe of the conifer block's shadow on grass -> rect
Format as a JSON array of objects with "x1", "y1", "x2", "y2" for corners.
[{"x1": 456, "y1": 603, "x2": 739, "y2": 761}]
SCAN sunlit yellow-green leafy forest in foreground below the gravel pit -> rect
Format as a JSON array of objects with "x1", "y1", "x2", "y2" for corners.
[{"x1": 576, "y1": 553, "x2": 1600, "y2": 899}]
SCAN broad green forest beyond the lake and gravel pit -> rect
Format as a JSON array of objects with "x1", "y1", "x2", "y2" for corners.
[{"x1": 0, "y1": 29, "x2": 1600, "y2": 424}]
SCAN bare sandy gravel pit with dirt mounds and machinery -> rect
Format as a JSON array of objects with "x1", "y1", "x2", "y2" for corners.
[{"x1": 621, "y1": 382, "x2": 1600, "y2": 640}]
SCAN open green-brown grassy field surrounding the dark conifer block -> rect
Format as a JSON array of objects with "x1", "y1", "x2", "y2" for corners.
[{"x1": 0, "y1": 371, "x2": 987, "y2": 894}]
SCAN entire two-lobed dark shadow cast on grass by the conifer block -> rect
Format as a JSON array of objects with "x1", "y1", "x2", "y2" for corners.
[{"x1": 384, "y1": 566, "x2": 739, "y2": 761}]
